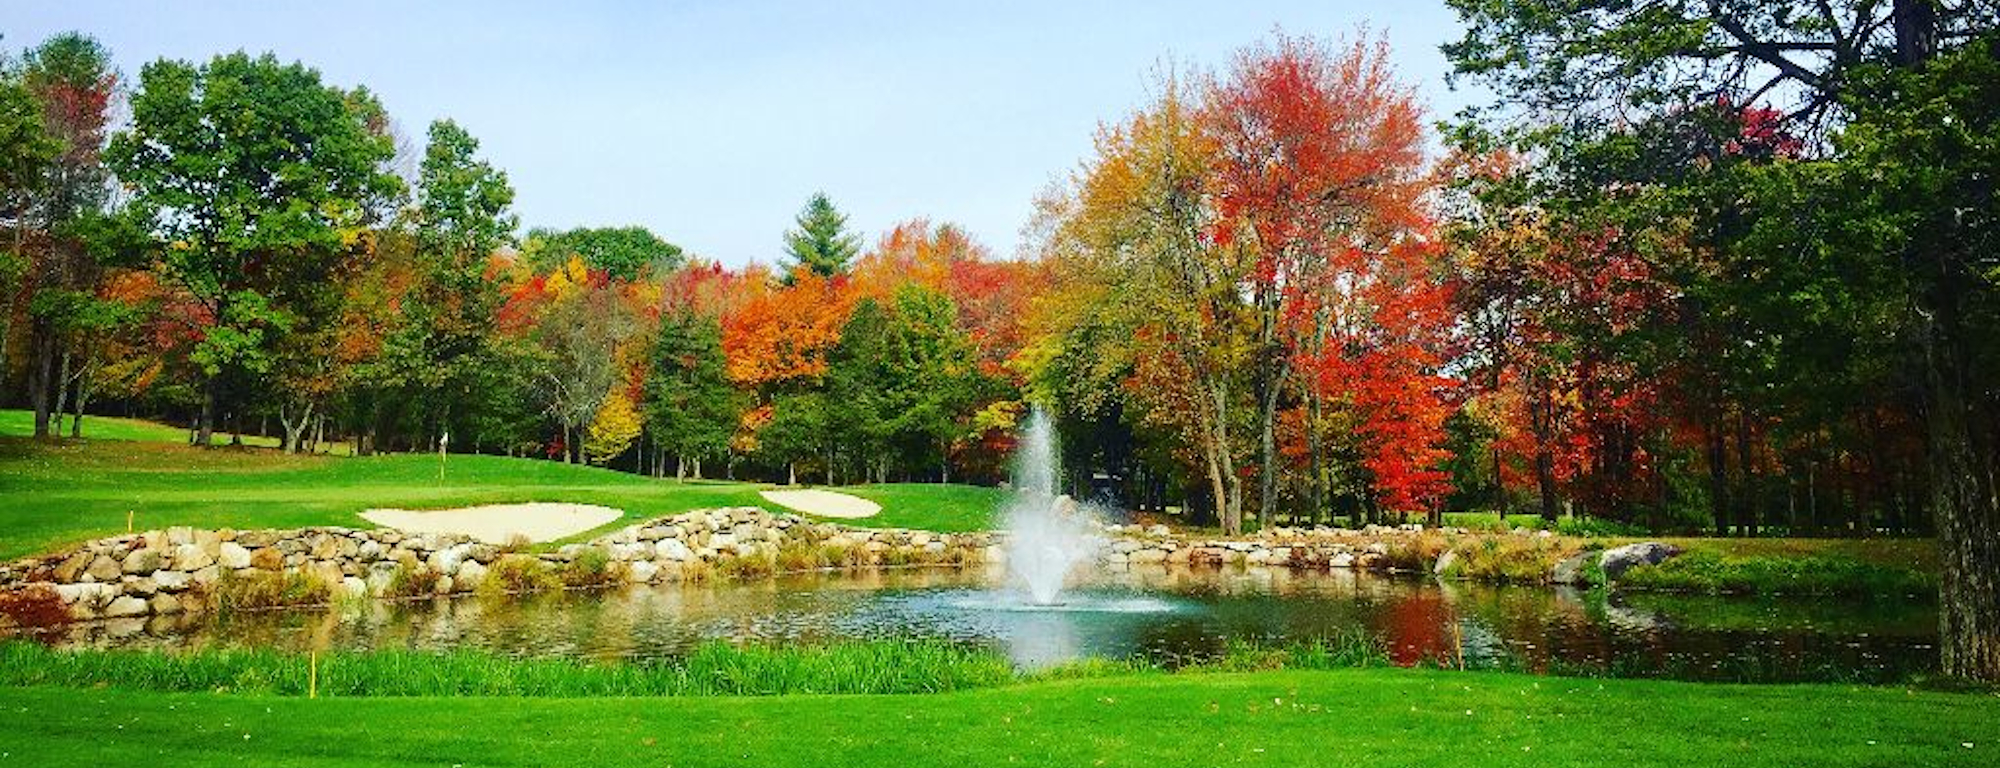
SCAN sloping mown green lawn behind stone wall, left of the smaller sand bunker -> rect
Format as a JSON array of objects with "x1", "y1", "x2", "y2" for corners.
[{"x1": 0, "y1": 438, "x2": 768, "y2": 558}]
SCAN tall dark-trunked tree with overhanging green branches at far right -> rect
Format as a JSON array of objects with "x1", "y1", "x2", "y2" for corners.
[{"x1": 1446, "y1": 0, "x2": 2000, "y2": 680}]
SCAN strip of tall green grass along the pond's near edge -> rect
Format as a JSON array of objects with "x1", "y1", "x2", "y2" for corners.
[{"x1": 0, "y1": 636, "x2": 1388, "y2": 696}]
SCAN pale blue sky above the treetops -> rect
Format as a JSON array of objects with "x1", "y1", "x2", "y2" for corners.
[{"x1": 0, "y1": 0, "x2": 1466, "y2": 264}]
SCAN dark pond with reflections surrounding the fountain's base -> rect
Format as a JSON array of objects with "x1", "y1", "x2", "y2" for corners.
[{"x1": 3, "y1": 568, "x2": 1936, "y2": 682}]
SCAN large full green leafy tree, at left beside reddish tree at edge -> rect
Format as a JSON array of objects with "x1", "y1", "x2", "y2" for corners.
[{"x1": 108, "y1": 52, "x2": 400, "y2": 444}]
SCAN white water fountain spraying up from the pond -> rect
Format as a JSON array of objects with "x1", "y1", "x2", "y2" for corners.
[{"x1": 1000, "y1": 408, "x2": 1098, "y2": 606}]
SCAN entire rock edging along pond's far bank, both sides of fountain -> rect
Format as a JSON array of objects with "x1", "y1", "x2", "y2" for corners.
[{"x1": 0, "y1": 508, "x2": 1672, "y2": 628}]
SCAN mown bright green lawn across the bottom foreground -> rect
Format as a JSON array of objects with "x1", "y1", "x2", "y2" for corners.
[{"x1": 0, "y1": 670, "x2": 2000, "y2": 768}]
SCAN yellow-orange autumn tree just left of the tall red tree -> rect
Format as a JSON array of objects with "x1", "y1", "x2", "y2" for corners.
[{"x1": 1038, "y1": 76, "x2": 1250, "y2": 534}]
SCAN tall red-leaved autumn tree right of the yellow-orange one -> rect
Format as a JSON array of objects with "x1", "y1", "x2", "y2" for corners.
[{"x1": 1204, "y1": 36, "x2": 1428, "y2": 524}]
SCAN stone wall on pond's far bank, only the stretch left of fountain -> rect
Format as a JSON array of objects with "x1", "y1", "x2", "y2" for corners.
[{"x1": 0, "y1": 508, "x2": 1000, "y2": 628}]
